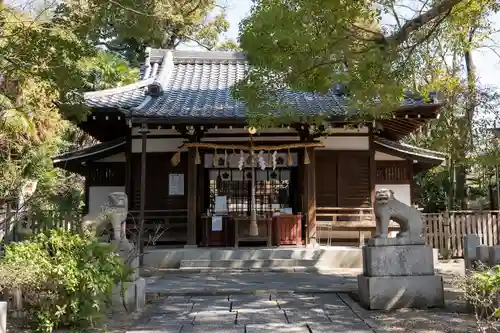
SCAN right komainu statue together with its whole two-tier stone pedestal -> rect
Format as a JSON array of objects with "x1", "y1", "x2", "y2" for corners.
[{"x1": 358, "y1": 190, "x2": 444, "y2": 310}]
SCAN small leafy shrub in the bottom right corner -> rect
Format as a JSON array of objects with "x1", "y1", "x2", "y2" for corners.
[{"x1": 457, "y1": 265, "x2": 500, "y2": 332}]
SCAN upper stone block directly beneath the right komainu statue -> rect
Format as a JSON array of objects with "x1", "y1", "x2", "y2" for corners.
[{"x1": 363, "y1": 245, "x2": 434, "y2": 276}]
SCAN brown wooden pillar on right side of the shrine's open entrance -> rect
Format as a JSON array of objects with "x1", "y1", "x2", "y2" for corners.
[{"x1": 299, "y1": 148, "x2": 317, "y2": 247}]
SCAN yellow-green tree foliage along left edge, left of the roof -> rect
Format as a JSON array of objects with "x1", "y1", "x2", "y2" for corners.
[{"x1": 0, "y1": 3, "x2": 138, "y2": 208}]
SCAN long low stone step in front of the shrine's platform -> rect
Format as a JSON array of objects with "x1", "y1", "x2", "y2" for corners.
[{"x1": 179, "y1": 259, "x2": 317, "y2": 270}]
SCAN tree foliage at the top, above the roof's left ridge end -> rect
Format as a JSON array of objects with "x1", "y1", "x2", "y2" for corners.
[{"x1": 57, "y1": 0, "x2": 229, "y2": 66}]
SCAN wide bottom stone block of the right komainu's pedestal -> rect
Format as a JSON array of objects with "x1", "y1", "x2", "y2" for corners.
[{"x1": 358, "y1": 275, "x2": 444, "y2": 310}]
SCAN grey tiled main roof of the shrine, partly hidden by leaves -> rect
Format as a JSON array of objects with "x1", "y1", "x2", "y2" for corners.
[{"x1": 84, "y1": 49, "x2": 440, "y2": 119}]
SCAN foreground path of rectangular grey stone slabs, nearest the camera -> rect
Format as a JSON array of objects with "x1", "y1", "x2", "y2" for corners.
[{"x1": 131, "y1": 293, "x2": 374, "y2": 333}]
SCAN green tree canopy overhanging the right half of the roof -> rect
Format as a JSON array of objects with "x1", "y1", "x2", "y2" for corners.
[{"x1": 235, "y1": 0, "x2": 498, "y2": 126}]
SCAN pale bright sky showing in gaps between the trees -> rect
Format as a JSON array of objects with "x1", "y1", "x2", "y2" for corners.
[{"x1": 217, "y1": 0, "x2": 500, "y2": 87}]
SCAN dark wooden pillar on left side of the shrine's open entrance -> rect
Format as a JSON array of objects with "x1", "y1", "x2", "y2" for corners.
[{"x1": 186, "y1": 148, "x2": 198, "y2": 247}]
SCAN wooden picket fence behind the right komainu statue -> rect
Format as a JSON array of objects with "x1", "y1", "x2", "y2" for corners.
[{"x1": 423, "y1": 211, "x2": 500, "y2": 258}]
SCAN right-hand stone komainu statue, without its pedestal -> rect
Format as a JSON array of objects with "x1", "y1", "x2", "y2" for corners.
[{"x1": 374, "y1": 189, "x2": 423, "y2": 240}]
